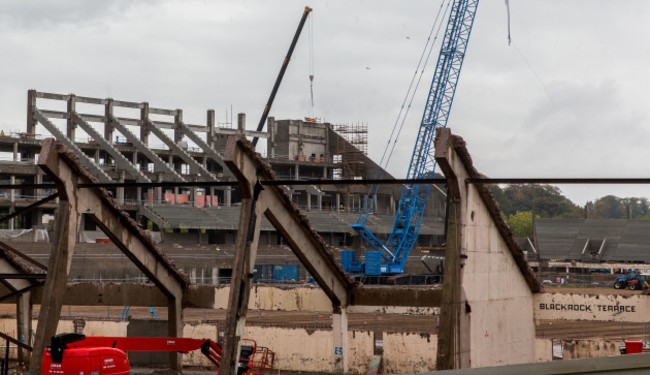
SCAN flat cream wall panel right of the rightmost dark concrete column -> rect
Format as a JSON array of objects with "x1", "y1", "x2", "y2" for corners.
[{"x1": 461, "y1": 176, "x2": 535, "y2": 367}]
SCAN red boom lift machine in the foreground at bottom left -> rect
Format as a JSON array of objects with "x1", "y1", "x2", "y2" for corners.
[{"x1": 42, "y1": 333, "x2": 275, "y2": 375}]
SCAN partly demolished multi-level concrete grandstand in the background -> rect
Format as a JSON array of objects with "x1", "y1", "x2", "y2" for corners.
[{"x1": 0, "y1": 91, "x2": 445, "y2": 280}]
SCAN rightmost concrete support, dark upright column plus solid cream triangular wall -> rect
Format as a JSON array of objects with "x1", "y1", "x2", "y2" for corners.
[{"x1": 435, "y1": 129, "x2": 541, "y2": 370}]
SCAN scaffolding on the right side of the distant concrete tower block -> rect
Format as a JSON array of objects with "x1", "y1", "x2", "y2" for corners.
[{"x1": 334, "y1": 123, "x2": 368, "y2": 178}]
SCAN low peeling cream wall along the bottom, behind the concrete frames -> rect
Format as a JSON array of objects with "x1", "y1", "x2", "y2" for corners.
[{"x1": 0, "y1": 318, "x2": 437, "y2": 374}]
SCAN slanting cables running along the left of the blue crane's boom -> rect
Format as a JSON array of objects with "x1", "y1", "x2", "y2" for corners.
[{"x1": 357, "y1": 0, "x2": 453, "y2": 223}]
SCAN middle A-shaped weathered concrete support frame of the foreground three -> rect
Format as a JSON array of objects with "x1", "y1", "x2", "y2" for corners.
[{"x1": 221, "y1": 135, "x2": 356, "y2": 375}]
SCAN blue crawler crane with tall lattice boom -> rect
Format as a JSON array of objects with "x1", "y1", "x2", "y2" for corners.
[{"x1": 341, "y1": 0, "x2": 479, "y2": 275}]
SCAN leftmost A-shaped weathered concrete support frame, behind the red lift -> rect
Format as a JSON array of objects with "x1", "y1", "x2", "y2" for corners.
[{"x1": 30, "y1": 139, "x2": 189, "y2": 374}]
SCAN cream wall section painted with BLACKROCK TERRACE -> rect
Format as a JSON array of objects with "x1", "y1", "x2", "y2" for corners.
[{"x1": 535, "y1": 293, "x2": 650, "y2": 323}]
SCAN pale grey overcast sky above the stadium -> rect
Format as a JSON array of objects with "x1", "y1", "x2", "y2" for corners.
[{"x1": 0, "y1": 0, "x2": 650, "y2": 204}]
